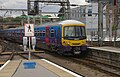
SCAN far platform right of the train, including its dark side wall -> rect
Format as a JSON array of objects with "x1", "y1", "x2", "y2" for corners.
[{"x1": 88, "y1": 46, "x2": 120, "y2": 67}]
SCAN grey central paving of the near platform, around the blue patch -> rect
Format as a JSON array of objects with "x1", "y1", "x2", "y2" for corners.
[{"x1": 13, "y1": 61, "x2": 59, "y2": 77}]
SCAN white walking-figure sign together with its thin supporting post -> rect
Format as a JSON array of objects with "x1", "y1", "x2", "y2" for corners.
[{"x1": 24, "y1": 24, "x2": 34, "y2": 60}]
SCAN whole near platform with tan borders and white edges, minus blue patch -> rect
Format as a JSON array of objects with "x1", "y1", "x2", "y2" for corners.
[{"x1": 0, "y1": 59, "x2": 83, "y2": 77}]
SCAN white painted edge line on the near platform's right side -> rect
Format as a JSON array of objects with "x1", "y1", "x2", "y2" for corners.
[{"x1": 41, "y1": 59, "x2": 83, "y2": 77}]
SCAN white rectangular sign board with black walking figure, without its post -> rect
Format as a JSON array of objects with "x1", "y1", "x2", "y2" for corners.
[{"x1": 24, "y1": 24, "x2": 34, "y2": 36}]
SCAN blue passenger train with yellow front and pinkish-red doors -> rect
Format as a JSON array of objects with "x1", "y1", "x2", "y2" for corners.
[{"x1": 0, "y1": 20, "x2": 87, "y2": 55}]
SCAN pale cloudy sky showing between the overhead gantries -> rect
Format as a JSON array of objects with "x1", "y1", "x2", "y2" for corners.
[{"x1": 0, "y1": 0, "x2": 86, "y2": 16}]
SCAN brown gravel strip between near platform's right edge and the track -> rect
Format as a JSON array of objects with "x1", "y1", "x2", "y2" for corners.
[{"x1": 33, "y1": 53, "x2": 115, "y2": 77}]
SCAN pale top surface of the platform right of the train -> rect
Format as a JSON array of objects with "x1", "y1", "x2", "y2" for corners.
[{"x1": 88, "y1": 46, "x2": 120, "y2": 53}]
